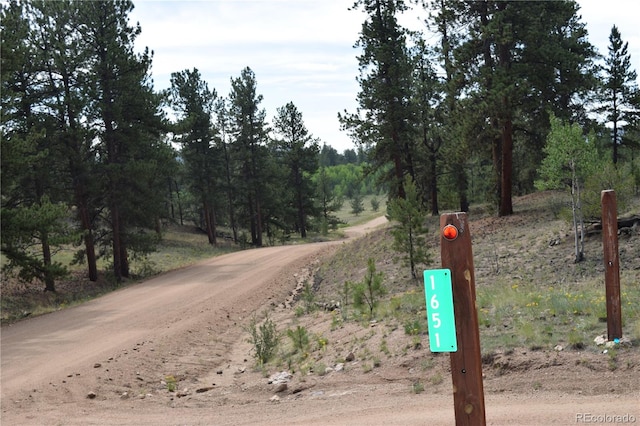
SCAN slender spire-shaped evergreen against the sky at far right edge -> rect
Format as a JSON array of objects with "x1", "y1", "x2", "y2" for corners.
[{"x1": 600, "y1": 25, "x2": 640, "y2": 164}]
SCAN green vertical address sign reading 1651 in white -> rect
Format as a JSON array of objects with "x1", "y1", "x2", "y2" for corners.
[{"x1": 424, "y1": 269, "x2": 458, "y2": 352}]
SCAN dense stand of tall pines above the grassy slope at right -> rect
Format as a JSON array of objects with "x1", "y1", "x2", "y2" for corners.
[{"x1": 340, "y1": 0, "x2": 640, "y2": 215}]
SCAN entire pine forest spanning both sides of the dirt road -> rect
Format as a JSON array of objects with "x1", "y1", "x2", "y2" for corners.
[{"x1": 1, "y1": 0, "x2": 640, "y2": 291}]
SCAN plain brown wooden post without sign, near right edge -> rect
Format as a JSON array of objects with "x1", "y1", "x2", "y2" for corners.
[{"x1": 600, "y1": 190, "x2": 622, "y2": 340}]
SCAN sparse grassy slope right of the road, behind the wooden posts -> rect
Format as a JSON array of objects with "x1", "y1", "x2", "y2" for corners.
[{"x1": 318, "y1": 188, "x2": 640, "y2": 353}]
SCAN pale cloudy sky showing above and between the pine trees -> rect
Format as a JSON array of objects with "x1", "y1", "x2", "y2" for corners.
[{"x1": 130, "y1": 0, "x2": 640, "y2": 152}]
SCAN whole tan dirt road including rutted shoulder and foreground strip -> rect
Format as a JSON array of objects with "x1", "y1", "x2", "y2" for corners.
[{"x1": 1, "y1": 218, "x2": 640, "y2": 426}]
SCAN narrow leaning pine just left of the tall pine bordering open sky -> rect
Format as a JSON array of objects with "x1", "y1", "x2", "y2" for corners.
[{"x1": 33, "y1": 0, "x2": 100, "y2": 281}]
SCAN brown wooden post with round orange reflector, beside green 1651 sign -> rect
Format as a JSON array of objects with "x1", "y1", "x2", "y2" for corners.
[{"x1": 440, "y1": 213, "x2": 486, "y2": 426}]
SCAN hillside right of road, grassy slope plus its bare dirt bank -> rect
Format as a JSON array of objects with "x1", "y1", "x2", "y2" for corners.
[{"x1": 260, "y1": 192, "x2": 640, "y2": 394}]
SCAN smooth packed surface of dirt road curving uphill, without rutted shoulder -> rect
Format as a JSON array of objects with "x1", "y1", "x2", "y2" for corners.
[{"x1": 0, "y1": 217, "x2": 386, "y2": 407}]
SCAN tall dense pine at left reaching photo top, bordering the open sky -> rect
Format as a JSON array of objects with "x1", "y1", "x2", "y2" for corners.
[{"x1": 80, "y1": 0, "x2": 164, "y2": 281}]
